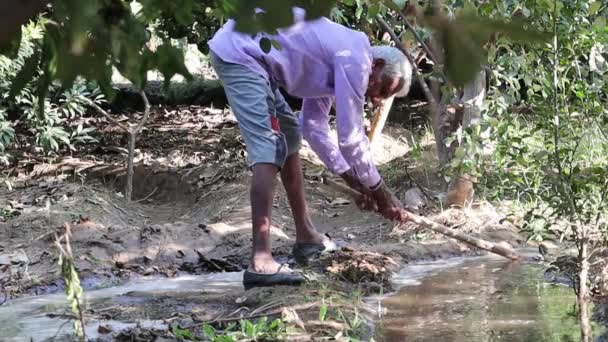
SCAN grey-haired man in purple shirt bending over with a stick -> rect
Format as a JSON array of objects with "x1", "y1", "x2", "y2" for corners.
[{"x1": 209, "y1": 8, "x2": 412, "y2": 288}]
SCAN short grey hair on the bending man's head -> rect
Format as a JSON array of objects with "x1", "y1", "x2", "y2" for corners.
[{"x1": 372, "y1": 45, "x2": 412, "y2": 97}]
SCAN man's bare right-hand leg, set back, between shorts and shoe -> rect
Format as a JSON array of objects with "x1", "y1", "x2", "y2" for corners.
[{"x1": 282, "y1": 153, "x2": 324, "y2": 244}]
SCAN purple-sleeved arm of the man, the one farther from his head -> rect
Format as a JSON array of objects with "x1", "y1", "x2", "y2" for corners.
[{"x1": 302, "y1": 97, "x2": 350, "y2": 175}]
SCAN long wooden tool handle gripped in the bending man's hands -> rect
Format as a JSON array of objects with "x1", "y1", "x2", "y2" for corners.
[{"x1": 323, "y1": 177, "x2": 520, "y2": 260}]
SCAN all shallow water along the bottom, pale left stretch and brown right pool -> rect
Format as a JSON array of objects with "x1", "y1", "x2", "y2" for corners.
[{"x1": 0, "y1": 252, "x2": 608, "y2": 342}]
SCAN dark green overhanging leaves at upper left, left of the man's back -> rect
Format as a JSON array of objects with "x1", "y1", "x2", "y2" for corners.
[{"x1": 6, "y1": 0, "x2": 191, "y2": 104}]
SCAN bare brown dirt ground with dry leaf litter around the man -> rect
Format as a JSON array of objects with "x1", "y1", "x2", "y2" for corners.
[{"x1": 0, "y1": 103, "x2": 524, "y2": 340}]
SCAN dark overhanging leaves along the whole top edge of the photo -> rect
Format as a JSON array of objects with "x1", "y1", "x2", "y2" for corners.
[{"x1": 0, "y1": 0, "x2": 547, "y2": 98}]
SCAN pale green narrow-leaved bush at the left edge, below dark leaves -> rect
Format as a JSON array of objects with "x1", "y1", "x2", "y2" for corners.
[{"x1": 0, "y1": 19, "x2": 104, "y2": 156}]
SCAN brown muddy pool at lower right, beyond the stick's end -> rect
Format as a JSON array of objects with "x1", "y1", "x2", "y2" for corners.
[{"x1": 378, "y1": 252, "x2": 600, "y2": 342}]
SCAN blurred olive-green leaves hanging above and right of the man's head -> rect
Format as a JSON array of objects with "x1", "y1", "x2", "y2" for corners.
[{"x1": 332, "y1": 0, "x2": 550, "y2": 86}]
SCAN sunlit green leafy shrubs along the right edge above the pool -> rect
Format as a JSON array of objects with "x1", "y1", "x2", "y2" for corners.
[{"x1": 454, "y1": 1, "x2": 608, "y2": 239}]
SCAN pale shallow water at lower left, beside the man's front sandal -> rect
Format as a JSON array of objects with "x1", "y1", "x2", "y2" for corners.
[{"x1": 0, "y1": 272, "x2": 242, "y2": 342}]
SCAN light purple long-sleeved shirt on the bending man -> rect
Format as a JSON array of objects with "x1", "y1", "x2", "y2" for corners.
[{"x1": 209, "y1": 9, "x2": 381, "y2": 188}]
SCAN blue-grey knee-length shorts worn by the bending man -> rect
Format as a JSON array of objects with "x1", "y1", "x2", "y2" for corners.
[{"x1": 210, "y1": 52, "x2": 302, "y2": 168}]
